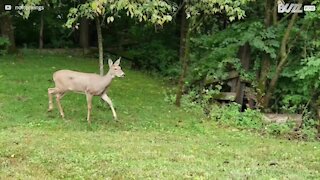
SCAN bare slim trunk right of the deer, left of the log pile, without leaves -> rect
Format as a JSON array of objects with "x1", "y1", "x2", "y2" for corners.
[{"x1": 175, "y1": 6, "x2": 190, "y2": 107}]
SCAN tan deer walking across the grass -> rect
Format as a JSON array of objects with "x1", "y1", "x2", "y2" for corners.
[{"x1": 48, "y1": 57, "x2": 125, "y2": 125}]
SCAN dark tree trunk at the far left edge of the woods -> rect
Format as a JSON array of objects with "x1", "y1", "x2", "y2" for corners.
[{"x1": 0, "y1": 13, "x2": 17, "y2": 53}]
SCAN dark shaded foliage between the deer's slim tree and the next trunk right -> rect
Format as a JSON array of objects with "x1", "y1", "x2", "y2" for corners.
[{"x1": 104, "y1": 17, "x2": 179, "y2": 76}]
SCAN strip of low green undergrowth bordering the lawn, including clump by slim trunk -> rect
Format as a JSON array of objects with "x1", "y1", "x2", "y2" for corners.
[{"x1": 164, "y1": 91, "x2": 317, "y2": 140}]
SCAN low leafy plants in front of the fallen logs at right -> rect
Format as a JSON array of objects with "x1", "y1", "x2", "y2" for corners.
[{"x1": 210, "y1": 104, "x2": 317, "y2": 141}]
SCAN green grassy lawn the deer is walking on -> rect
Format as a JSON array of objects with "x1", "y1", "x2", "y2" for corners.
[{"x1": 0, "y1": 53, "x2": 320, "y2": 180}]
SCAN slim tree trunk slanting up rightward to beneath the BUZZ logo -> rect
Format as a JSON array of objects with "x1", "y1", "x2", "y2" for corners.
[{"x1": 263, "y1": 10, "x2": 301, "y2": 107}]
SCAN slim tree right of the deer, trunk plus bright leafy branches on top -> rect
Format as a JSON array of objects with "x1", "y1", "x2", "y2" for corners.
[{"x1": 175, "y1": 0, "x2": 249, "y2": 106}]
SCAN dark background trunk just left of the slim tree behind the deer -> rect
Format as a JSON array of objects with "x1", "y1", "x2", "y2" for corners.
[{"x1": 80, "y1": 18, "x2": 89, "y2": 54}]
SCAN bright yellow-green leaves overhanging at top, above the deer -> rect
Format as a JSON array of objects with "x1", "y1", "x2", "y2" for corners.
[{"x1": 65, "y1": 0, "x2": 175, "y2": 28}]
